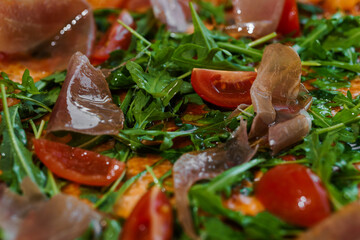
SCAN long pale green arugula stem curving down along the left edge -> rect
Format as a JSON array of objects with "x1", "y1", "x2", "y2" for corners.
[{"x1": 0, "y1": 84, "x2": 37, "y2": 183}]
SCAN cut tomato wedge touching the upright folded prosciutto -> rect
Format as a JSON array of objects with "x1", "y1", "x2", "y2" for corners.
[{"x1": 191, "y1": 68, "x2": 257, "y2": 108}]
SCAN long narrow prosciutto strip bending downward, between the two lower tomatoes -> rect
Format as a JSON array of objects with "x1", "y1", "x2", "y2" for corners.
[{"x1": 173, "y1": 121, "x2": 257, "y2": 239}]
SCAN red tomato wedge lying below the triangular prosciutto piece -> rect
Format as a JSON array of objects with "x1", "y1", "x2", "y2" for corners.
[{"x1": 34, "y1": 139, "x2": 125, "y2": 186}]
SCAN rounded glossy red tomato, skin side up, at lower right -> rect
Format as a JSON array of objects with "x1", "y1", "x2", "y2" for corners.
[{"x1": 255, "y1": 164, "x2": 331, "y2": 227}]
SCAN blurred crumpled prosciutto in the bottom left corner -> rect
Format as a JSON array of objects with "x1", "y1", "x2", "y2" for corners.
[{"x1": 0, "y1": 178, "x2": 102, "y2": 240}]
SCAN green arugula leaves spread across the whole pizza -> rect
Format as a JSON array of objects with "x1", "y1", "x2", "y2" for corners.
[{"x1": 0, "y1": 3, "x2": 360, "y2": 239}]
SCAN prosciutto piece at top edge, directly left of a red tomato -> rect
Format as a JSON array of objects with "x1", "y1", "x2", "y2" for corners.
[{"x1": 227, "y1": 0, "x2": 285, "y2": 37}]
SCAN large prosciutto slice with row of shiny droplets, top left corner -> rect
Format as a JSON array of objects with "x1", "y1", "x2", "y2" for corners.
[{"x1": 0, "y1": 0, "x2": 95, "y2": 70}]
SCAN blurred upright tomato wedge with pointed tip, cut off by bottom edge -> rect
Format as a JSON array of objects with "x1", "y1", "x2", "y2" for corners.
[{"x1": 120, "y1": 187, "x2": 173, "y2": 240}]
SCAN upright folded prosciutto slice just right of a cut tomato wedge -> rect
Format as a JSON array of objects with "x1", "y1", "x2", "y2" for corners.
[{"x1": 249, "y1": 43, "x2": 311, "y2": 154}]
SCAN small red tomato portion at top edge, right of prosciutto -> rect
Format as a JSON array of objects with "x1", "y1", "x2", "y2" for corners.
[{"x1": 276, "y1": 0, "x2": 300, "y2": 36}]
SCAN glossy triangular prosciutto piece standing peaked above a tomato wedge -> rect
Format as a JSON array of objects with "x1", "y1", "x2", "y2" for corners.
[{"x1": 47, "y1": 52, "x2": 124, "y2": 135}]
